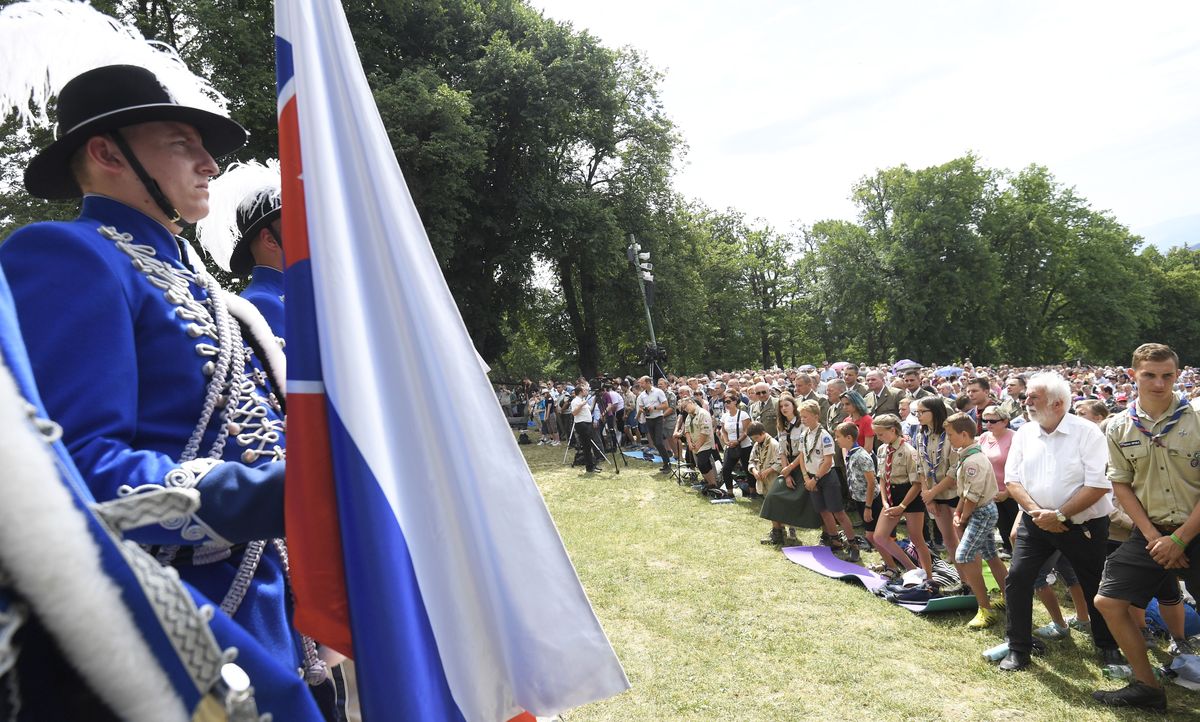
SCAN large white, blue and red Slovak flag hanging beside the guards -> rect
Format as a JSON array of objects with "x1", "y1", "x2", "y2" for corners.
[{"x1": 275, "y1": 0, "x2": 629, "y2": 722}]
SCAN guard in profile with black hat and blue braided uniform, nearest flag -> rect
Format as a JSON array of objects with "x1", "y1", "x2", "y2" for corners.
[{"x1": 0, "y1": 56, "x2": 325, "y2": 710}]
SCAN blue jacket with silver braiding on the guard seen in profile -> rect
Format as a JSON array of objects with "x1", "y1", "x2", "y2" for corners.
[{"x1": 0, "y1": 195, "x2": 299, "y2": 669}]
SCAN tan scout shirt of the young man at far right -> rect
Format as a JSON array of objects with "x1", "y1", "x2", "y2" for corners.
[{"x1": 1106, "y1": 402, "x2": 1200, "y2": 527}]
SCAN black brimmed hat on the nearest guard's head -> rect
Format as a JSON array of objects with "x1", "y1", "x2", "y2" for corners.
[{"x1": 25, "y1": 65, "x2": 246, "y2": 199}]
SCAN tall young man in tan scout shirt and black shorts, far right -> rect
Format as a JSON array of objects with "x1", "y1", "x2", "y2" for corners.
[{"x1": 1093, "y1": 343, "x2": 1200, "y2": 711}]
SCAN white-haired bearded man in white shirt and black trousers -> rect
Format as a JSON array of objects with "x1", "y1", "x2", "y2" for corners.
[{"x1": 1000, "y1": 373, "x2": 1122, "y2": 672}]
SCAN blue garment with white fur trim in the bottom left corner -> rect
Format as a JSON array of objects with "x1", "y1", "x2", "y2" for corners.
[{"x1": 0, "y1": 250, "x2": 322, "y2": 722}]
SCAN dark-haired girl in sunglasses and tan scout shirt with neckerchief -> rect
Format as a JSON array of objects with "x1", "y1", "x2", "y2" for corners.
[{"x1": 917, "y1": 396, "x2": 959, "y2": 559}]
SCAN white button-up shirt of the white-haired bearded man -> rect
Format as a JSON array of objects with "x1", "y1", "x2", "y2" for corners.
[{"x1": 1004, "y1": 414, "x2": 1112, "y2": 524}]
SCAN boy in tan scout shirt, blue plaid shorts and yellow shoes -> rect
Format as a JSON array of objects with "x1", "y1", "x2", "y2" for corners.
[{"x1": 946, "y1": 413, "x2": 1008, "y2": 630}]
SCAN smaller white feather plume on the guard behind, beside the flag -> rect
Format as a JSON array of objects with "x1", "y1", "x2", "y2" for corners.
[{"x1": 196, "y1": 158, "x2": 280, "y2": 271}]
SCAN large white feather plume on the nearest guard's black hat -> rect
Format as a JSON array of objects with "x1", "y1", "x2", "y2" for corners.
[{"x1": 0, "y1": 0, "x2": 229, "y2": 126}]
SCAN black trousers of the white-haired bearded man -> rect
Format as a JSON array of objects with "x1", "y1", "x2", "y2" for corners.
[{"x1": 1004, "y1": 516, "x2": 1117, "y2": 654}]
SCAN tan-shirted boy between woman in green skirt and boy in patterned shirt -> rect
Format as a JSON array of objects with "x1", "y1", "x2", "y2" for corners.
[{"x1": 799, "y1": 401, "x2": 859, "y2": 561}]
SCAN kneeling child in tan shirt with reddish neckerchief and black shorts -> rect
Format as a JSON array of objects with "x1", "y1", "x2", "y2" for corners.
[{"x1": 871, "y1": 414, "x2": 934, "y2": 579}]
